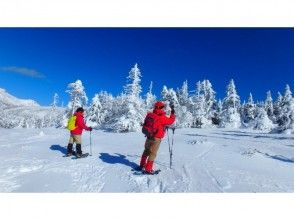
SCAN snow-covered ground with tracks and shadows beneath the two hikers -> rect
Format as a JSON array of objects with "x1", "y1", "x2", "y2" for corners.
[{"x1": 0, "y1": 128, "x2": 294, "y2": 192}]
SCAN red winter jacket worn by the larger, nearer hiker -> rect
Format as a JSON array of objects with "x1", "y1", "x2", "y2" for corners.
[{"x1": 153, "y1": 109, "x2": 176, "y2": 138}]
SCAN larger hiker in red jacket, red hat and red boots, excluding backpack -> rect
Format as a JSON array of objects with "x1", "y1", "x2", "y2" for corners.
[{"x1": 140, "y1": 102, "x2": 176, "y2": 174}]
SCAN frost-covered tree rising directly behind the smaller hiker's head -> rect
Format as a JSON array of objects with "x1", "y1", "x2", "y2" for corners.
[{"x1": 66, "y1": 80, "x2": 88, "y2": 115}]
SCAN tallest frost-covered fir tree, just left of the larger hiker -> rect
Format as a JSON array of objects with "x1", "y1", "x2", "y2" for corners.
[{"x1": 111, "y1": 64, "x2": 146, "y2": 132}]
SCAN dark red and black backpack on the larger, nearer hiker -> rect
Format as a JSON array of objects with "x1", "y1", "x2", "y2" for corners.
[{"x1": 142, "y1": 112, "x2": 159, "y2": 138}]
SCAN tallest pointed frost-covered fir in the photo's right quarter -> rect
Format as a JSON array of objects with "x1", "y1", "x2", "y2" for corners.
[{"x1": 221, "y1": 79, "x2": 241, "y2": 128}]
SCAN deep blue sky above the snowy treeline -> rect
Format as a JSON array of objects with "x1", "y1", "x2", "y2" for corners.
[{"x1": 0, "y1": 28, "x2": 294, "y2": 105}]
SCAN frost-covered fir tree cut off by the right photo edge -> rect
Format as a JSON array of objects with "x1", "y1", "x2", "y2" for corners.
[{"x1": 278, "y1": 85, "x2": 294, "y2": 132}]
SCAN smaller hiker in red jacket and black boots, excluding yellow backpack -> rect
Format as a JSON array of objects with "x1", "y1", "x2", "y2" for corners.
[{"x1": 66, "y1": 107, "x2": 92, "y2": 157}]
